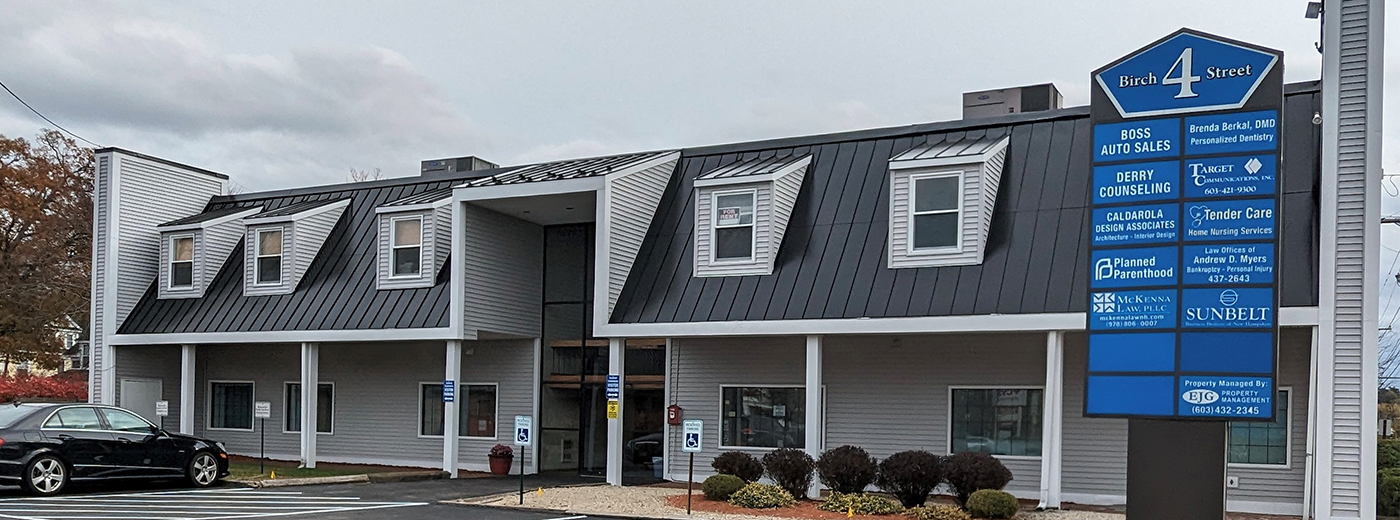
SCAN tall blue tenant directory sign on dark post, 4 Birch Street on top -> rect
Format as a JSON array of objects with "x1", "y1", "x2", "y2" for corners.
[{"x1": 1084, "y1": 29, "x2": 1284, "y2": 520}]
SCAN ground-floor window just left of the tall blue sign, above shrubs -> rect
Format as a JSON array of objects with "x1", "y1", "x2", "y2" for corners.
[{"x1": 952, "y1": 388, "x2": 1044, "y2": 457}]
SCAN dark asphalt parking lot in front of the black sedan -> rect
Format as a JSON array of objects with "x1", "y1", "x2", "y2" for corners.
[{"x1": 0, "y1": 477, "x2": 621, "y2": 520}]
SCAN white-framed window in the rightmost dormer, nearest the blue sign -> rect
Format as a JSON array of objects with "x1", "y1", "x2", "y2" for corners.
[{"x1": 909, "y1": 171, "x2": 962, "y2": 254}]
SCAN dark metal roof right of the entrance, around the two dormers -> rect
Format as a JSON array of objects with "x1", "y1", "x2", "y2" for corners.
[{"x1": 610, "y1": 83, "x2": 1320, "y2": 322}]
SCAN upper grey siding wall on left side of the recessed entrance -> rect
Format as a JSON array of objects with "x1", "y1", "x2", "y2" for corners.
[{"x1": 461, "y1": 205, "x2": 545, "y2": 338}]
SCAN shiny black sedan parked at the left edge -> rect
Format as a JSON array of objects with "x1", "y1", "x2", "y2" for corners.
[{"x1": 0, "y1": 404, "x2": 228, "y2": 495}]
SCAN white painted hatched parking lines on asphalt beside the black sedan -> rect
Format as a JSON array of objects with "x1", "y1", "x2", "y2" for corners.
[{"x1": 0, "y1": 489, "x2": 427, "y2": 520}]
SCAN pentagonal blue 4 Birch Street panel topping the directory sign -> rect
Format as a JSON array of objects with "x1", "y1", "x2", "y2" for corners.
[{"x1": 1093, "y1": 32, "x2": 1278, "y2": 118}]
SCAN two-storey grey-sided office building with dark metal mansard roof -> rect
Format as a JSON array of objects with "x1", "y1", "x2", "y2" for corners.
[{"x1": 92, "y1": 83, "x2": 1377, "y2": 514}]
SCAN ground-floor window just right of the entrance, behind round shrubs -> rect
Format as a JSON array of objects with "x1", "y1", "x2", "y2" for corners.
[{"x1": 720, "y1": 387, "x2": 806, "y2": 449}]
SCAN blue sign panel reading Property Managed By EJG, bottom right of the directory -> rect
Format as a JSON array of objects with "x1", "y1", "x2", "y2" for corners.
[{"x1": 1177, "y1": 376, "x2": 1274, "y2": 419}]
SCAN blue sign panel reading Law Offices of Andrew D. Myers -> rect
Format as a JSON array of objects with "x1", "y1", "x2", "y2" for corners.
[{"x1": 1182, "y1": 242, "x2": 1274, "y2": 286}]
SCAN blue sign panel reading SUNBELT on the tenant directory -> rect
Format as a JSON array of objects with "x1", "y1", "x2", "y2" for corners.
[{"x1": 1182, "y1": 287, "x2": 1274, "y2": 328}]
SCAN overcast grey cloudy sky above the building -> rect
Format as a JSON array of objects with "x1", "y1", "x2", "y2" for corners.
[{"x1": 8, "y1": 0, "x2": 1400, "y2": 367}]
